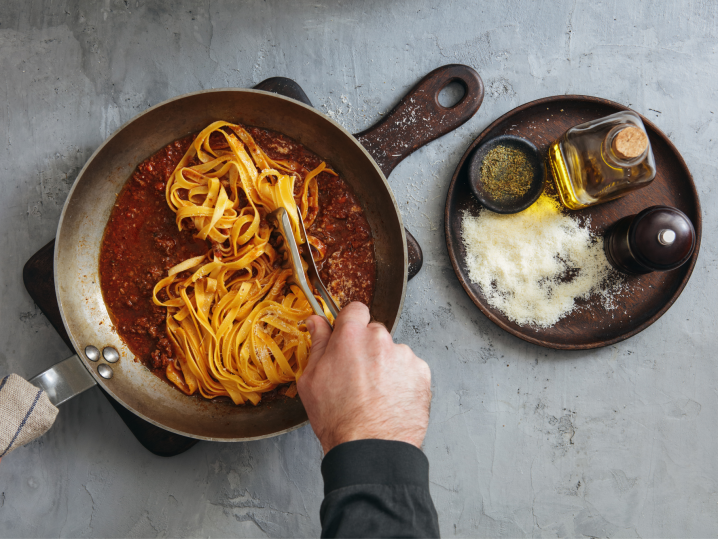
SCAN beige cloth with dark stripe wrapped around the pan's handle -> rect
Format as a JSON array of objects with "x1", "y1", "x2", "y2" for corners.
[{"x1": 0, "y1": 374, "x2": 58, "y2": 458}]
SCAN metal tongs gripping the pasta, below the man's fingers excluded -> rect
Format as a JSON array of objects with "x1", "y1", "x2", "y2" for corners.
[{"x1": 267, "y1": 208, "x2": 339, "y2": 327}]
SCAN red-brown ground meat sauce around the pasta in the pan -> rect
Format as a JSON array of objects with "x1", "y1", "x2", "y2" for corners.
[{"x1": 100, "y1": 128, "x2": 376, "y2": 377}]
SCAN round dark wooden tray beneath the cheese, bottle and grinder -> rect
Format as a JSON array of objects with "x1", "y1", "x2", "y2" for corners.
[{"x1": 444, "y1": 95, "x2": 702, "y2": 350}]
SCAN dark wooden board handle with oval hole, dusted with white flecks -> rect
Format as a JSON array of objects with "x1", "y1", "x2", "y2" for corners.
[{"x1": 354, "y1": 64, "x2": 484, "y2": 176}]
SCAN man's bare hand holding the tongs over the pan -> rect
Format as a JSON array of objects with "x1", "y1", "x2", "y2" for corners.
[{"x1": 297, "y1": 302, "x2": 431, "y2": 454}]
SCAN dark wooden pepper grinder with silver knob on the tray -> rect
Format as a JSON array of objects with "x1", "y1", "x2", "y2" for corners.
[{"x1": 603, "y1": 206, "x2": 696, "y2": 275}]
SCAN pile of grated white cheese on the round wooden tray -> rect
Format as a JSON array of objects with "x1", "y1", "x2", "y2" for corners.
[{"x1": 462, "y1": 195, "x2": 621, "y2": 328}]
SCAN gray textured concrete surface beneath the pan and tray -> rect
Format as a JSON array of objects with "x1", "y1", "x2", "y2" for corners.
[{"x1": 0, "y1": 0, "x2": 718, "y2": 537}]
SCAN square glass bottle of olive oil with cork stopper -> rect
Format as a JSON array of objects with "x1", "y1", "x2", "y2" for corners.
[{"x1": 548, "y1": 111, "x2": 656, "y2": 210}]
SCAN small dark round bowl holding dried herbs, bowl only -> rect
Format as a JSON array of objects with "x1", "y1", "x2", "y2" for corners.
[{"x1": 468, "y1": 135, "x2": 544, "y2": 213}]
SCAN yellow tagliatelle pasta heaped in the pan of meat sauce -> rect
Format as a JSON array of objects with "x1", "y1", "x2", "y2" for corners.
[{"x1": 153, "y1": 122, "x2": 334, "y2": 404}]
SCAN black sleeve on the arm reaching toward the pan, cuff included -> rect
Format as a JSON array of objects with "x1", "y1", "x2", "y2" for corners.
[{"x1": 319, "y1": 440, "x2": 439, "y2": 537}]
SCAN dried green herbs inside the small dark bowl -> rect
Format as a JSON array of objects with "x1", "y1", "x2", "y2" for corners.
[{"x1": 481, "y1": 146, "x2": 534, "y2": 200}]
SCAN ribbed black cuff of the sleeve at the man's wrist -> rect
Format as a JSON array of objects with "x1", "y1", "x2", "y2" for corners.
[{"x1": 322, "y1": 440, "x2": 429, "y2": 496}]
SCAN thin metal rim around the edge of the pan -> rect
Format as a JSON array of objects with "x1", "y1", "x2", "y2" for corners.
[{"x1": 53, "y1": 87, "x2": 409, "y2": 442}]
